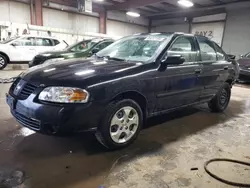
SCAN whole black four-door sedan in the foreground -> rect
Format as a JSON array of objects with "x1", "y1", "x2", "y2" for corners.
[{"x1": 6, "y1": 33, "x2": 236, "y2": 149}]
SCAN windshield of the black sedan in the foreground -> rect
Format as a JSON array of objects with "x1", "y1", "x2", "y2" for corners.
[{"x1": 96, "y1": 34, "x2": 171, "y2": 62}]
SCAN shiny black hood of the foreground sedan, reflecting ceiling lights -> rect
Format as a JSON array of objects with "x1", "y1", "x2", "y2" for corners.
[{"x1": 21, "y1": 58, "x2": 142, "y2": 87}]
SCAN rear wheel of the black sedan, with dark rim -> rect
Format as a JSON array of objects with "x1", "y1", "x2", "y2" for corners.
[{"x1": 208, "y1": 83, "x2": 231, "y2": 112}]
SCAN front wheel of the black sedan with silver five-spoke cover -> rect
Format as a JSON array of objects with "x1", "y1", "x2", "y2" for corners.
[{"x1": 95, "y1": 99, "x2": 143, "y2": 150}]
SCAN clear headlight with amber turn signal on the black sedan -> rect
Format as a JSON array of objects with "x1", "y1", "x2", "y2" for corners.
[{"x1": 38, "y1": 87, "x2": 89, "y2": 103}]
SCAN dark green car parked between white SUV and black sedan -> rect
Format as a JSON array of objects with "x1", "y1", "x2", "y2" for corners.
[{"x1": 29, "y1": 39, "x2": 114, "y2": 67}]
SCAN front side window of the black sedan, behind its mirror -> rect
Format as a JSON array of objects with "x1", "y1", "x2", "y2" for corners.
[{"x1": 168, "y1": 36, "x2": 197, "y2": 62}]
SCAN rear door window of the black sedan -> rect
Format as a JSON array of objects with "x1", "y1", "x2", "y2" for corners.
[{"x1": 197, "y1": 37, "x2": 217, "y2": 61}]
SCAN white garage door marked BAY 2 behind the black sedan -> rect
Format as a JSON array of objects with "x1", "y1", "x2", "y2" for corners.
[{"x1": 192, "y1": 22, "x2": 225, "y2": 46}]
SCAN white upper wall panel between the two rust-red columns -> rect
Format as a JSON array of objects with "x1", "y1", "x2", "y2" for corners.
[{"x1": 43, "y1": 8, "x2": 99, "y2": 33}]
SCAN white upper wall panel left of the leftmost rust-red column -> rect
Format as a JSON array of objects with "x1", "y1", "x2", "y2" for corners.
[{"x1": 0, "y1": 1, "x2": 30, "y2": 24}]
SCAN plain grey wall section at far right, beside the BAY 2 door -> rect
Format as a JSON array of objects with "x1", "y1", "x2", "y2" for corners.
[{"x1": 223, "y1": 9, "x2": 250, "y2": 56}]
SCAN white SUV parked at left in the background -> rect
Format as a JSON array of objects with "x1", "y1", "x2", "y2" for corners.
[{"x1": 0, "y1": 35, "x2": 68, "y2": 70}]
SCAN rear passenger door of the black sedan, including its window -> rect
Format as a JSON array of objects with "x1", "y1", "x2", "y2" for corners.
[{"x1": 196, "y1": 36, "x2": 231, "y2": 101}]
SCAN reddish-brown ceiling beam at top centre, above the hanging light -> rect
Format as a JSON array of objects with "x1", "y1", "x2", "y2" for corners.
[{"x1": 109, "y1": 0, "x2": 163, "y2": 10}]
